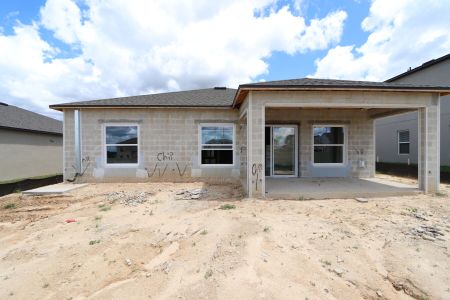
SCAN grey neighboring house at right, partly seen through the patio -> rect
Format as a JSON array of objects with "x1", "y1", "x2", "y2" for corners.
[{"x1": 376, "y1": 54, "x2": 450, "y2": 166}]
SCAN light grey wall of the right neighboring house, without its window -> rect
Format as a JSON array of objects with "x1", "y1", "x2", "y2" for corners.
[{"x1": 376, "y1": 59, "x2": 450, "y2": 166}]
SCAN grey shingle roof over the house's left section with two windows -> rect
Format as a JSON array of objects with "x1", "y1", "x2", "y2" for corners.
[{"x1": 50, "y1": 87, "x2": 236, "y2": 109}]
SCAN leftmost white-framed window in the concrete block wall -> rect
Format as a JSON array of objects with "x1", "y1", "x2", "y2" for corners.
[{"x1": 105, "y1": 125, "x2": 139, "y2": 165}]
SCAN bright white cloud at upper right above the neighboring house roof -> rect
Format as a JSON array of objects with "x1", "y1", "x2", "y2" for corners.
[{"x1": 312, "y1": 0, "x2": 450, "y2": 80}]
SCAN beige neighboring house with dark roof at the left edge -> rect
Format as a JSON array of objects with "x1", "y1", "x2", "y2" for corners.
[{"x1": 0, "y1": 103, "x2": 63, "y2": 183}]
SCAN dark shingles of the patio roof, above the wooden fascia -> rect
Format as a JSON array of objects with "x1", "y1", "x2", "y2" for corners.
[{"x1": 239, "y1": 78, "x2": 449, "y2": 91}]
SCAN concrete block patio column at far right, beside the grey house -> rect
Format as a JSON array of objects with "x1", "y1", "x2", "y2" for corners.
[{"x1": 418, "y1": 94, "x2": 440, "y2": 193}]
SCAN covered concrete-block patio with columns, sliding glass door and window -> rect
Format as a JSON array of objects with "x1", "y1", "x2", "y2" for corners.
[{"x1": 237, "y1": 80, "x2": 439, "y2": 199}]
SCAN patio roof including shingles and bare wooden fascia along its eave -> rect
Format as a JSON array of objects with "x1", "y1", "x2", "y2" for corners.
[{"x1": 234, "y1": 78, "x2": 450, "y2": 105}]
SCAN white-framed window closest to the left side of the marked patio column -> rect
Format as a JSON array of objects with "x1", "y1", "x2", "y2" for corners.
[{"x1": 200, "y1": 124, "x2": 234, "y2": 165}]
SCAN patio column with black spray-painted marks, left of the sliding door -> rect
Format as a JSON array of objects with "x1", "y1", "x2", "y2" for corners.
[{"x1": 247, "y1": 92, "x2": 266, "y2": 197}]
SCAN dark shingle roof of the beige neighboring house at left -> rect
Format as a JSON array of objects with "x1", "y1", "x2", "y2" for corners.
[{"x1": 0, "y1": 103, "x2": 63, "y2": 135}]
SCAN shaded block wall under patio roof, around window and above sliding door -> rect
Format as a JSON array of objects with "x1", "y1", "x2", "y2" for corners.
[{"x1": 266, "y1": 108, "x2": 375, "y2": 178}]
